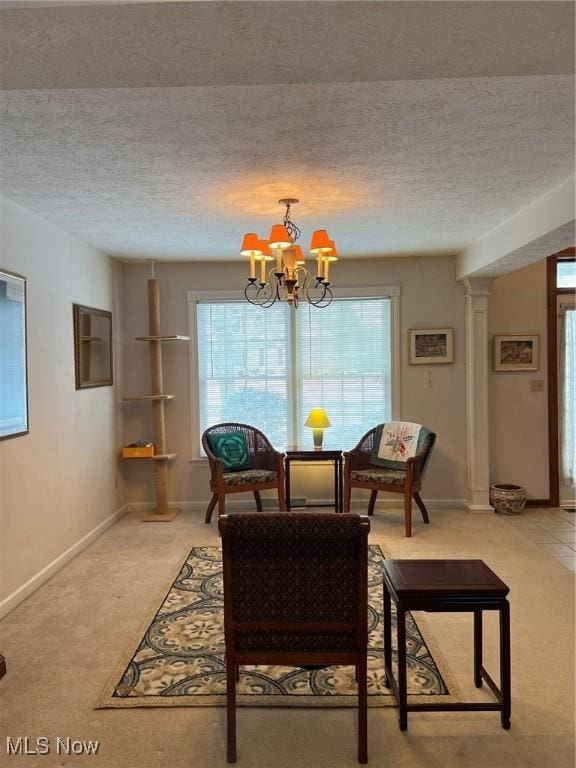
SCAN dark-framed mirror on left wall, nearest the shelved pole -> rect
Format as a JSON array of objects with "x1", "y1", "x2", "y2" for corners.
[{"x1": 74, "y1": 304, "x2": 112, "y2": 389}]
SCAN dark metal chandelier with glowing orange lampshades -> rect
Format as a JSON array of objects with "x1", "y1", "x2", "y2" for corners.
[{"x1": 240, "y1": 197, "x2": 338, "y2": 308}]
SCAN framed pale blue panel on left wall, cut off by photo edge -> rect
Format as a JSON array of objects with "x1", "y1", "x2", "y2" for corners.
[{"x1": 0, "y1": 267, "x2": 28, "y2": 440}]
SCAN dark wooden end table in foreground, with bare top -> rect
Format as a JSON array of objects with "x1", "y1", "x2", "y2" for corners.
[{"x1": 384, "y1": 560, "x2": 511, "y2": 731}]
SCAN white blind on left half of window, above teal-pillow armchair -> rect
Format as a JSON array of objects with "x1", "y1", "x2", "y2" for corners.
[{"x1": 197, "y1": 300, "x2": 290, "y2": 448}]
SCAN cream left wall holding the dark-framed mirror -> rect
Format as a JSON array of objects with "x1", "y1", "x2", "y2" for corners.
[{"x1": 0, "y1": 200, "x2": 125, "y2": 613}]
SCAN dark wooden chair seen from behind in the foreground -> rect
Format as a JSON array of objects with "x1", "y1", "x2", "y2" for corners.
[{"x1": 219, "y1": 512, "x2": 370, "y2": 763}]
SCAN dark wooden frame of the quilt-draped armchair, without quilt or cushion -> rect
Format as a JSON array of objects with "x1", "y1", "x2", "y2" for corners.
[{"x1": 344, "y1": 427, "x2": 436, "y2": 536}]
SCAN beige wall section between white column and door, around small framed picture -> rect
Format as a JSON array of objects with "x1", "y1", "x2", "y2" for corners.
[{"x1": 489, "y1": 260, "x2": 549, "y2": 499}]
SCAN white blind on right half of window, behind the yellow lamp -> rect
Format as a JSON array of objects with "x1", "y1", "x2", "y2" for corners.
[{"x1": 296, "y1": 298, "x2": 392, "y2": 450}]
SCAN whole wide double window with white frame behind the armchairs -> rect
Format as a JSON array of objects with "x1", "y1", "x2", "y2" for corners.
[{"x1": 189, "y1": 289, "x2": 397, "y2": 456}]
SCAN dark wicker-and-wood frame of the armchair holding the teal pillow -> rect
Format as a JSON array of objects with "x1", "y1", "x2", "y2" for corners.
[{"x1": 202, "y1": 422, "x2": 286, "y2": 523}]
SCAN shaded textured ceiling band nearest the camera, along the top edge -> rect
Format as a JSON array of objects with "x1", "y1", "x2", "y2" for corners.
[{"x1": 0, "y1": 1, "x2": 574, "y2": 88}]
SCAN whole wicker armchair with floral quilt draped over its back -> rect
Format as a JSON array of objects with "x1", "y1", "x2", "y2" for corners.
[{"x1": 344, "y1": 421, "x2": 436, "y2": 536}]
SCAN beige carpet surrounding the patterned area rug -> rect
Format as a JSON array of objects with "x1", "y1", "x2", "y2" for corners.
[{"x1": 0, "y1": 510, "x2": 576, "y2": 768}]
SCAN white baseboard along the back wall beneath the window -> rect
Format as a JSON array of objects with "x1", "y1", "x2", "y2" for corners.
[{"x1": 126, "y1": 494, "x2": 466, "y2": 512}]
